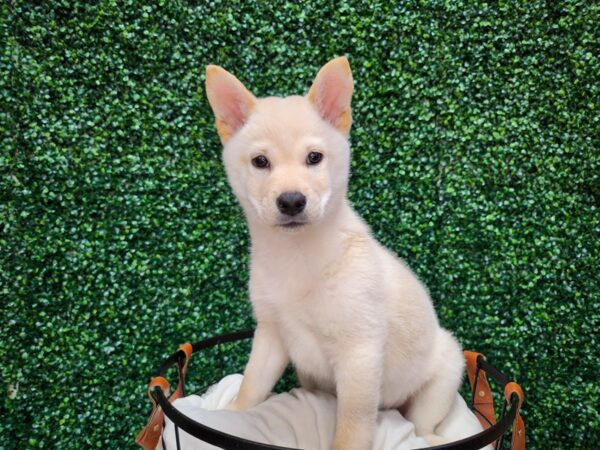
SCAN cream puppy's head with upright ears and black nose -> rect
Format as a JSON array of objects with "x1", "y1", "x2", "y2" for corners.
[{"x1": 206, "y1": 57, "x2": 353, "y2": 230}]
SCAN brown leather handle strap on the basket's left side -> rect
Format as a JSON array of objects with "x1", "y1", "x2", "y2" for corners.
[{"x1": 135, "y1": 343, "x2": 193, "y2": 450}]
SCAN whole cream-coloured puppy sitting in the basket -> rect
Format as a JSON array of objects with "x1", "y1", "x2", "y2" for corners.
[{"x1": 206, "y1": 57, "x2": 464, "y2": 450}]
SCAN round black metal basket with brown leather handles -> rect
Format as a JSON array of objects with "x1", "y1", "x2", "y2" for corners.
[{"x1": 136, "y1": 330, "x2": 525, "y2": 450}]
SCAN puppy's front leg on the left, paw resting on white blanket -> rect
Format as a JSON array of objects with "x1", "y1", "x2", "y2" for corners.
[{"x1": 228, "y1": 323, "x2": 289, "y2": 411}]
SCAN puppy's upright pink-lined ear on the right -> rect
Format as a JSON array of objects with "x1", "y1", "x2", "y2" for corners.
[{"x1": 308, "y1": 56, "x2": 354, "y2": 135}]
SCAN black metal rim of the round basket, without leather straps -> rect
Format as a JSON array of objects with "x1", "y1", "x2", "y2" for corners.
[{"x1": 151, "y1": 330, "x2": 519, "y2": 450}]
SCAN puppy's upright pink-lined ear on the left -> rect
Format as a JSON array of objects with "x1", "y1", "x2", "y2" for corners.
[{"x1": 206, "y1": 65, "x2": 256, "y2": 144}]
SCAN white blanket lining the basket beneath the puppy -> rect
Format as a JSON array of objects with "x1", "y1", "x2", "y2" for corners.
[{"x1": 157, "y1": 375, "x2": 489, "y2": 450}]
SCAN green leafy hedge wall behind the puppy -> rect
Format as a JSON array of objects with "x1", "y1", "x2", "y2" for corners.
[{"x1": 0, "y1": 0, "x2": 600, "y2": 449}]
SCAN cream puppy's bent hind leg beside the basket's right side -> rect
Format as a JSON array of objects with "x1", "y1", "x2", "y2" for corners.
[{"x1": 405, "y1": 329, "x2": 464, "y2": 445}]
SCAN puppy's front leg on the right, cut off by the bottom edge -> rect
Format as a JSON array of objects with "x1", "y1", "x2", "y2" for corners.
[{"x1": 333, "y1": 347, "x2": 383, "y2": 450}]
